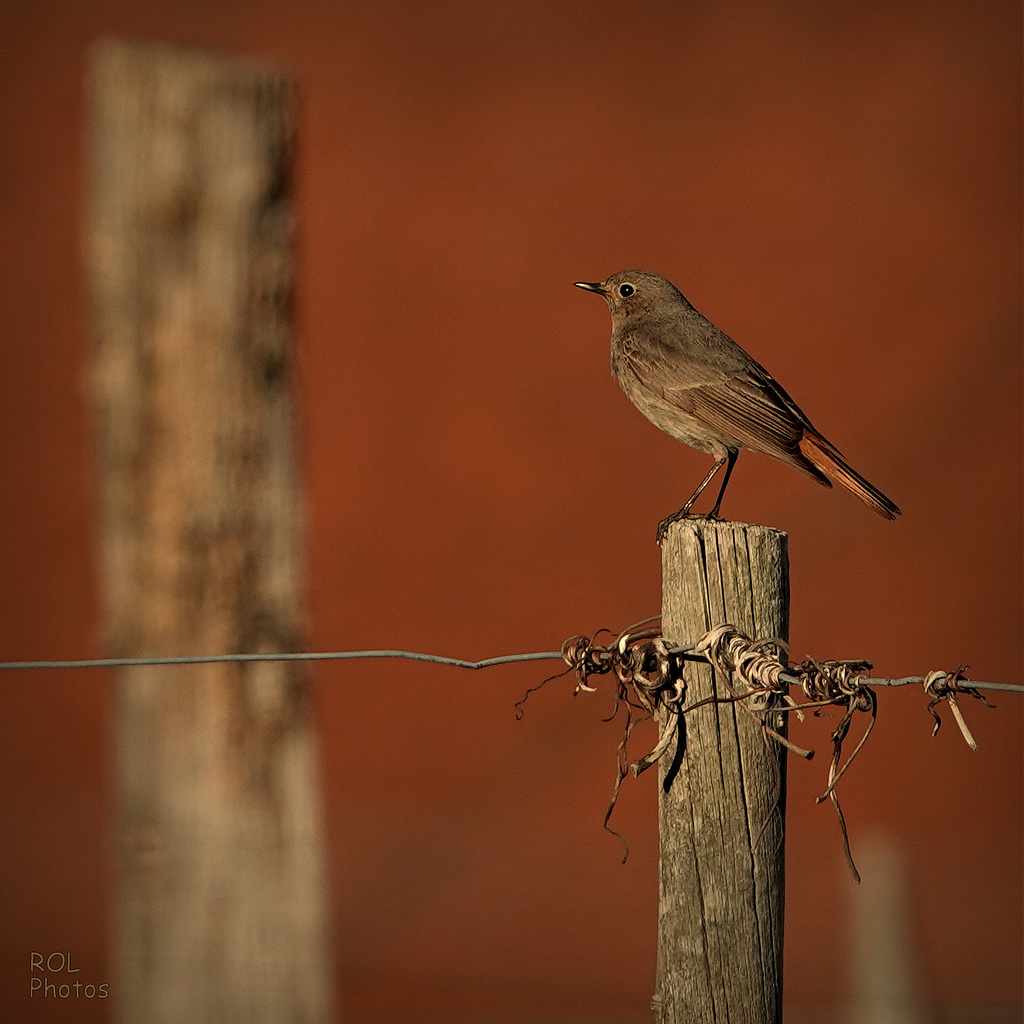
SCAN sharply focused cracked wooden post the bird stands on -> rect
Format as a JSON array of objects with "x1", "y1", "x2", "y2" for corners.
[{"x1": 653, "y1": 519, "x2": 790, "y2": 1024}]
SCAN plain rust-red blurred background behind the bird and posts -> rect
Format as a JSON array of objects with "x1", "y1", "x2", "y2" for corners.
[{"x1": 0, "y1": 0, "x2": 1022, "y2": 1024}]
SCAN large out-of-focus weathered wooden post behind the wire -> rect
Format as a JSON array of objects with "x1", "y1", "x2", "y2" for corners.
[{"x1": 88, "y1": 42, "x2": 330, "y2": 1024}]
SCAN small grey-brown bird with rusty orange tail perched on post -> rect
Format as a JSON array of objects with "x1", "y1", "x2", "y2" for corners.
[{"x1": 577, "y1": 270, "x2": 899, "y2": 540}]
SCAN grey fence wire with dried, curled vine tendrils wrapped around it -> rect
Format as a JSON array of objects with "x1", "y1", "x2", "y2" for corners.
[{"x1": 0, "y1": 616, "x2": 1024, "y2": 882}]
